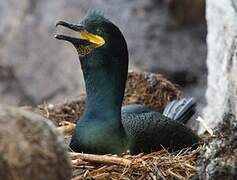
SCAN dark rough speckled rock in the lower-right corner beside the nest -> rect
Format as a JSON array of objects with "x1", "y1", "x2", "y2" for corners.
[{"x1": 196, "y1": 114, "x2": 237, "y2": 180}]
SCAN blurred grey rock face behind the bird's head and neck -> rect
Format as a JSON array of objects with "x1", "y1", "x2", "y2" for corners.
[{"x1": 0, "y1": 0, "x2": 206, "y2": 104}]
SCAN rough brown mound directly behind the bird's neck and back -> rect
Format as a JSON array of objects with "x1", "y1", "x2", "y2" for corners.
[{"x1": 124, "y1": 71, "x2": 180, "y2": 111}]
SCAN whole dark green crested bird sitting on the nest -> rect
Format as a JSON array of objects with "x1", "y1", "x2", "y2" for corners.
[{"x1": 55, "y1": 12, "x2": 199, "y2": 154}]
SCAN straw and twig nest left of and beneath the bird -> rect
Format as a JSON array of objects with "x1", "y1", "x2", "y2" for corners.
[{"x1": 22, "y1": 101, "x2": 202, "y2": 180}]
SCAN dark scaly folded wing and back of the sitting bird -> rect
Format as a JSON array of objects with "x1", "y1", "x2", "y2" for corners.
[{"x1": 122, "y1": 111, "x2": 198, "y2": 154}]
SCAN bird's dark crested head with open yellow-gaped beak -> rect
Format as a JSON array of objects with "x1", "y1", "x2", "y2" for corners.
[{"x1": 55, "y1": 12, "x2": 128, "y2": 68}]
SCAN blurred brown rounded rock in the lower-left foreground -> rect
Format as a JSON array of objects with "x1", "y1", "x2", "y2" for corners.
[{"x1": 0, "y1": 105, "x2": 71, "y2": 180}]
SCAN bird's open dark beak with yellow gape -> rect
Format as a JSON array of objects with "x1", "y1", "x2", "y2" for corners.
[{"x1": 55, "y1": 21, "x2": 105, "y2": 47}]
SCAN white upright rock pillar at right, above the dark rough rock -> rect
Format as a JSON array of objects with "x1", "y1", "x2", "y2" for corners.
[{"x1": 200, "y1": 0, "x2": 237, "y2": 132}]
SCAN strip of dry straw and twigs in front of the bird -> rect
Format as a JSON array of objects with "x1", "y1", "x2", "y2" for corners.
[{"x1": 71, "y1": 148, "x2": 200, "y2": 180}]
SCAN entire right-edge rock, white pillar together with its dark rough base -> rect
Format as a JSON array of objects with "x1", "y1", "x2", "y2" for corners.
[{"x1": 190, "y1": 0, "x2": 237, "y2": 177}]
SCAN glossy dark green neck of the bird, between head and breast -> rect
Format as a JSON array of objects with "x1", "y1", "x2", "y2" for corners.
[{"x1": 82, "y1": 59, "x2": 127, "y2": 123}]
